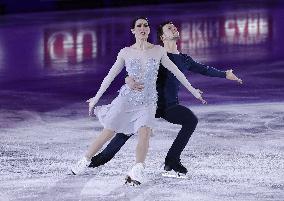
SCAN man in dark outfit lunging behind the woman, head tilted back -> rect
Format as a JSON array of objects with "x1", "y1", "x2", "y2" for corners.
[{"x1": 79, "y1": 21, "x2": 242, "y2": 177}]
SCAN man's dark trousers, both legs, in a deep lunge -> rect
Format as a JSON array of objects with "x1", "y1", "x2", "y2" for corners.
[{"x1": 89, "y1": 105, "x2": 198, "y2": 167}]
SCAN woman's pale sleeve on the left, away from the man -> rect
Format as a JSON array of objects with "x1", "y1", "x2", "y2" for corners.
[{"x1": 94, "y1": 50, "x2": 124, "y2": 102}]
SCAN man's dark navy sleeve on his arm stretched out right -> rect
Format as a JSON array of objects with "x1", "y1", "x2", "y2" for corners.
[{"x1": 183, "y1": 55, "x2": 226, "y2": 78}]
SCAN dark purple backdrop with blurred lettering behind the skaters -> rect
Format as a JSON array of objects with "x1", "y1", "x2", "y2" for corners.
[{"x1": 0, "y1": 3, "x2": 284, "y2": 111}]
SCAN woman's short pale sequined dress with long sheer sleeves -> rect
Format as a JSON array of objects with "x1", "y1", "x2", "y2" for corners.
[{"x1": 94, "y1": 45, "x2": 200, "y2": 134}]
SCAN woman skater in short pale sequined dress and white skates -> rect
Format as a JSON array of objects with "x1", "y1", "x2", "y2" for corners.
[{"x1": 72, "y1": 17, "x2": 206, "y2": 185}]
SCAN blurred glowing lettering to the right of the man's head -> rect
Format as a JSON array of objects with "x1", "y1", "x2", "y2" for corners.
[{"x1": 180, "y1": 13, "x2": 269, "y2": 52}]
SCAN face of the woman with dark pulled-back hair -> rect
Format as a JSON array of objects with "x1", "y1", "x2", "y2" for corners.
[{"x1": 131, "y1": 19, "x2": 150, "y2": 40}]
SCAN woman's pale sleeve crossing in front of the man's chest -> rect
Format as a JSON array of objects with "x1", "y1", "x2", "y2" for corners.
[{"x1": 161, "y1": 48, "x2": 201, "y2": 98}]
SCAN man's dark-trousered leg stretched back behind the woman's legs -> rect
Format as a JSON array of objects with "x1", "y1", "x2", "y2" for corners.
[{"x1": 89, "y1": 133, "x2": 132, "y2": 168}]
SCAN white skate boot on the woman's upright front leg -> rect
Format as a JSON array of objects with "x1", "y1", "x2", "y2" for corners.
[{"x1": 125, "y1": 163, "x2": 145, "y2": 186}]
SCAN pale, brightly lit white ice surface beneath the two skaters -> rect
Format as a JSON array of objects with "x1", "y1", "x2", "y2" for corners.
[{"x1": 0, "y1": 102, "x2": 284, "y2": 201}]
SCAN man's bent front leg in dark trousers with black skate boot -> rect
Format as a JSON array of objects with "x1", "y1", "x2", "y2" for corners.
[{"x1": 163, "y1": 105, "x2": 198, "y2": 173}]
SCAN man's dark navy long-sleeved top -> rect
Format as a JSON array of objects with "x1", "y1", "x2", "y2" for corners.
[{"x1": 156, "y1": 53, "x2": 226, "y2": 113}]
